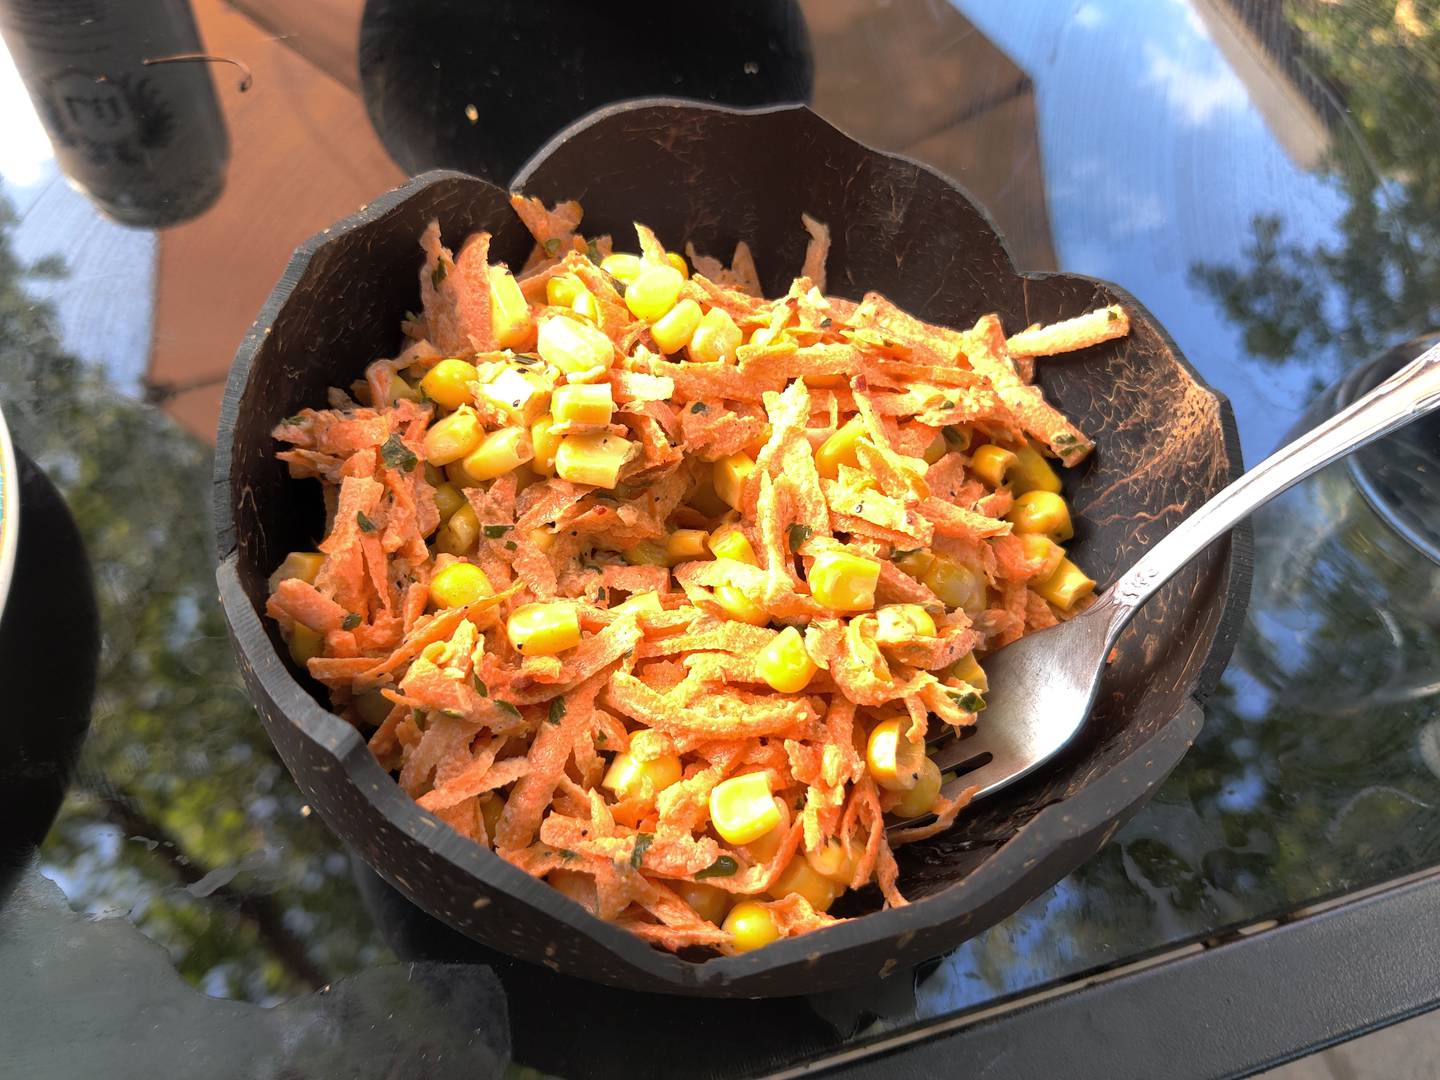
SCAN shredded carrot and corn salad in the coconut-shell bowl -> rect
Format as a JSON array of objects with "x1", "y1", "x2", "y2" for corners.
[{"x1": 268, "y1": 196, "x2": 1129, "y2": 953}]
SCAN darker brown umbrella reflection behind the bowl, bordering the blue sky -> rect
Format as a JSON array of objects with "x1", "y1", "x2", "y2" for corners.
[{"x1": 801, "y1": 0, "x2": 1056, "y2": 269}]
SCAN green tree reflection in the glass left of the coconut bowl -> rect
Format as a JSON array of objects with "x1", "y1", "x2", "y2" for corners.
[{"x1": 0, "y1": 199, "x2": 377, "y2": 999}]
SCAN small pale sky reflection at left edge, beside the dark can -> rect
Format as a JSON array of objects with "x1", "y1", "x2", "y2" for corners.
[{"x1": 0, "y1": 48, "x2": 157, "y2": 393}]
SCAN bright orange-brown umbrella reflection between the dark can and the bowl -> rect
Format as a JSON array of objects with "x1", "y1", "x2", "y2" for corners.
[{"x1": 145, "y1": 0, "x2": 405, "y2": 441}]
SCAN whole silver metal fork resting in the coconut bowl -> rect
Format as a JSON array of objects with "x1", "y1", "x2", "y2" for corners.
[{"x1": 906, "y1": 346, "x2": 1440, "y2": 824}]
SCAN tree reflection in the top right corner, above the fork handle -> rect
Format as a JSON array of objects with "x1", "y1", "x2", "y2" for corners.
[{"x1": 1192, "y1": 0, "x2": 1440, "y2": 361}]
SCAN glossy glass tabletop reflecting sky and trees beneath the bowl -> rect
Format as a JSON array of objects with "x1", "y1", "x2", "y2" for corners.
[{"x1": 0, "y1": 0, "x2": 1440, "y2": 1076}]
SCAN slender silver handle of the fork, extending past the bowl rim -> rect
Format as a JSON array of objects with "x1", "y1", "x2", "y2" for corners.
[{"x1": 1097, "y1": 346, "x2": 1440, "y2": 638}]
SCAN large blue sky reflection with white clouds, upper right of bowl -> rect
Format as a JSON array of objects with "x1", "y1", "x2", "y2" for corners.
[{"x1": 955, "y1": 0, "x2": 1344, "y2": 462}]
